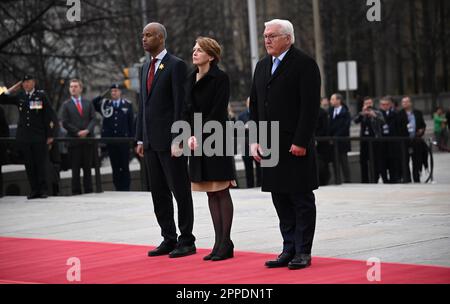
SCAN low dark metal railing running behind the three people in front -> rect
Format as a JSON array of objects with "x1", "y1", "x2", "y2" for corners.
[{"x1": 0, "y1": 137, "x2": 434, "y2": 193}]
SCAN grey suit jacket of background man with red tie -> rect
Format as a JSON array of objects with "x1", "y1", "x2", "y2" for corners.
[{"x1": 61, "y1": 98, "x2": 95, "y2": 141}]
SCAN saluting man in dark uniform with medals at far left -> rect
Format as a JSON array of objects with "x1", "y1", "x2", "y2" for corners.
[{"x1": 0, "y1": 75, "x2": 55, "y2": 199}]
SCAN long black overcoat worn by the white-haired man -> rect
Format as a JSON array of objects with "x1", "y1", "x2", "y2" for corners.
[{"x1": 250, "y1": 46, "x2": 321, "y2": 193}]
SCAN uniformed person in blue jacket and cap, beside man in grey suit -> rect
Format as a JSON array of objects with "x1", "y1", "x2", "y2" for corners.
[{"x1": 92, "y1": 84, "x2": 134, "y2": 191}]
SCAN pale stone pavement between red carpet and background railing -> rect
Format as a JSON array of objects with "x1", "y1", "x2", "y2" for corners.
[{"x1": 0, "y1": 153, "x2": 450, "y2": 266}]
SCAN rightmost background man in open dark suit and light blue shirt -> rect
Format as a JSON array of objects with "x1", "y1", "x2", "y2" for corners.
[{"x1": 398, "y1": 96, "x2": 427, "y2": 183}]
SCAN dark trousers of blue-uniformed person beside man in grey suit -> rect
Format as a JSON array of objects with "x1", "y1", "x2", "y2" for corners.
[{"x1": 107, "y1": 144, "x2": 130, "y2": 191}]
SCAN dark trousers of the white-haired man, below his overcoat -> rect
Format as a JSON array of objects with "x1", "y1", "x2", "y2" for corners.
[{"x1": 272, "y1": 191, "x2": 316, "y2": 254}]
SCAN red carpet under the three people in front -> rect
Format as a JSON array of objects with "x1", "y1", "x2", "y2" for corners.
[{"x1": 0, "y1": 237, "x2": 450, "y2": 284}]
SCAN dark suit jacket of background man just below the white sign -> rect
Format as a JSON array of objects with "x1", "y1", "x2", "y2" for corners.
[{"x1": 329, "y1": 106, "x2": 352, "y2": 153}]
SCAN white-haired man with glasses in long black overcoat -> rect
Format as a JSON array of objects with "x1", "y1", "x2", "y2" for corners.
[{"x1": 250, "y1": 19, "x2": 321, "y2": 269}]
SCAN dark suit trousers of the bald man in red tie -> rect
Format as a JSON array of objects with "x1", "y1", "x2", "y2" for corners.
[{"x1": 144, "y1": 149, "x2": 195, "y2": 246}]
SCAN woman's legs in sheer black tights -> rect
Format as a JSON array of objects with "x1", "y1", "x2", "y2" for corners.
[{"x1": 207, "y1": 189, "x2": 233, "y2": 252}]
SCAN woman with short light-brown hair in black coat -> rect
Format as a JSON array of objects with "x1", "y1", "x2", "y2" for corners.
[{"x1": 185, "y1": 37, "x2": 236, "y2": 261}]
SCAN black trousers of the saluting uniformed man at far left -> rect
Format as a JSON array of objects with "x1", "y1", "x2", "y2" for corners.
[{"x1": 18, "y1": 142, "x2": 49, "y2": 195}]
